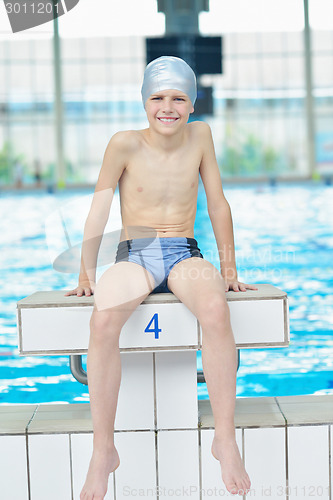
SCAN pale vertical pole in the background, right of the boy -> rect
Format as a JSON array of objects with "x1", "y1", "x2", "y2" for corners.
[{"x1": 303, "y1": 0, "x2": 316, "y2": 177}]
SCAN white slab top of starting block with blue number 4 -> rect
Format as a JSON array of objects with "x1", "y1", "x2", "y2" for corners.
[{"x1": 17, "y1": 284, "x2": 289, "y2": 356}]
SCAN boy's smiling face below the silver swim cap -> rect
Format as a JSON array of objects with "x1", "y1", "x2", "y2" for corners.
[{"x1": 145, "y1": 89, "x2": 194, "y2": 134}]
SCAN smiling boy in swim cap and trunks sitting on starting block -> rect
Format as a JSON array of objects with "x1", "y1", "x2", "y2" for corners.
[{"x1": 66, "y1": 56, "x2": 256, "y2": 500}]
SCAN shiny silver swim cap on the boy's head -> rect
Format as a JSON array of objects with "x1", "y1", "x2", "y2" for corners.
[{"x1": 141, "y1": 56, "x2": 197, "y2": 105}]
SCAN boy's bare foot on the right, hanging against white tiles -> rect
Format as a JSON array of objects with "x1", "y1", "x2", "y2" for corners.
[{"x1": 212, "y1": 437, "x2": 251, "y2": 496}]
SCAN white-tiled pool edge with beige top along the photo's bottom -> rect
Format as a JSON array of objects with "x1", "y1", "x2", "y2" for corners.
[{"x1": 0, "y1": 395, "x2": 333, "y2": 500}]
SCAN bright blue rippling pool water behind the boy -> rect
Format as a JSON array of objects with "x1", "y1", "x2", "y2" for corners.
[{"x1": 0, "y1": 183, "x2": 333, "y2": 403}]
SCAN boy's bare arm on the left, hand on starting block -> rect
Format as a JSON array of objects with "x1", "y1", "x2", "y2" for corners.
[{"x1": 65, "y1": 132, "x2": 127, "y2": 296}]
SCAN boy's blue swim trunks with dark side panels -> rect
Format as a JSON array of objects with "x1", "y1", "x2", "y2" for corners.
[{"x1": 115, "y1": 237, "x2": 203, "y2": 293}]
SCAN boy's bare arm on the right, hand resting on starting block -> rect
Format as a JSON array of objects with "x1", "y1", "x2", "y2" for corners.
[{"x1": 200, "y1": 123, "x2": 257, "y2": 291}]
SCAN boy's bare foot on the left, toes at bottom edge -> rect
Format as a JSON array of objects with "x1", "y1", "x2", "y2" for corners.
[{"x1": 80, "y1": 447, "x2": 120, "y2": 500}]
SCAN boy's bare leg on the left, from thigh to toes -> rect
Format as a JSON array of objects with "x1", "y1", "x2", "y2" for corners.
[{"x1": 80, "y1": 262, "x2": 154, "y2": 500}]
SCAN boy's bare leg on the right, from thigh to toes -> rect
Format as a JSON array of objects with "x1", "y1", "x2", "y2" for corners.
[{"x1": 168, "y1": 257, "x2": 250, "y2": 494}]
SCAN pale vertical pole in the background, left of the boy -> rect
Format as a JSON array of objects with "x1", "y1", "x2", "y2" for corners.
[{"x1": 53, "y1": 3, "x2": 66, "y2": 188}]
